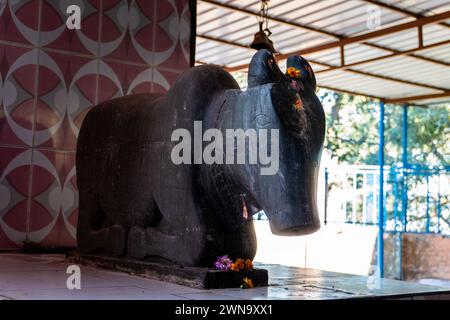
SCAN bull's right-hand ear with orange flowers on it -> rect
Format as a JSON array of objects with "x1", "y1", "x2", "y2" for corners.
[{"x1": 286, "y1": 55, "x2": 317, "y2": 92}]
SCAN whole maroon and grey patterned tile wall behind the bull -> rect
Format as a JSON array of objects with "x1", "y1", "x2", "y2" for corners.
[{"x1": 0, "y1": 0, "x2": 195, "y2": 250}]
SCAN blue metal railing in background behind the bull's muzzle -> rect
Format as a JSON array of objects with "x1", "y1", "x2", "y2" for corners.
[{"x1": 323, "y1": 165, "x2": 450, "y2": 235}]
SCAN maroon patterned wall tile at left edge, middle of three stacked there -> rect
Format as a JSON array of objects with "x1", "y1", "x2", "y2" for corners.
[{"x1": 0, "y1": 44, "x2": 37, "y2": 146}]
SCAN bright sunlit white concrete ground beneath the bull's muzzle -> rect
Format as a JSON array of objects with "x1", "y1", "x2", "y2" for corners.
[{"x1": 254, "y1": 221, "x2": 376, "y2": 276}]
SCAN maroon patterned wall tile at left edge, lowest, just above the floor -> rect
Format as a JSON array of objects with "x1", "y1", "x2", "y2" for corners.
[{"x1": 0, "y1": 147, "x2": 31, "y2": 249}]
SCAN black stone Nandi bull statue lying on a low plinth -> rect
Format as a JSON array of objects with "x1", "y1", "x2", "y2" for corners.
[{"x1": 76, "y1": 50, "x2": 325, "y2": 267}]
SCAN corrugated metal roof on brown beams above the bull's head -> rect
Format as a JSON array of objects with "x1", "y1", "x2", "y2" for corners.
[{"x1": 196, "y1": 0, "x2": 450, "y2": 104}]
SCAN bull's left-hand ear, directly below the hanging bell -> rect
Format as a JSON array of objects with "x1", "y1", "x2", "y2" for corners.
[{"x1": 248, "y1": 49, "x2": 286, "y2": 88}]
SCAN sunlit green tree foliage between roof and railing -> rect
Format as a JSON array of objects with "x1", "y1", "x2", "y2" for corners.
[{"x1": 318, "y1": 90, "x2": 450, "y2": 165}]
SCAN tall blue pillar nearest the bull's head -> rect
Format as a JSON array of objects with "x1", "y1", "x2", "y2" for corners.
[{"x1": 377, "y1": 101, "x2": 384, "y2": 278}]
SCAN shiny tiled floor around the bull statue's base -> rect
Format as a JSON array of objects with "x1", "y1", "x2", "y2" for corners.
[{"x1": 0, "y1": 253, "x2": 450, "y2": 300}]
